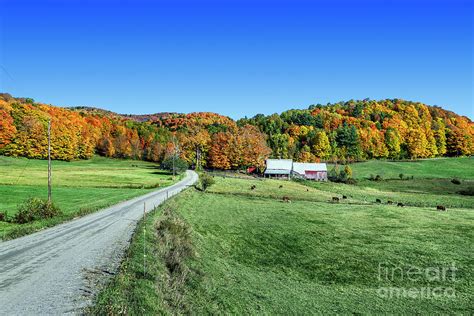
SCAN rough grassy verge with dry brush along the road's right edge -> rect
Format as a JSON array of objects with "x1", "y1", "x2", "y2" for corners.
[{"x1": 90, "y1": 199, "x2": 193, "y2": 315}]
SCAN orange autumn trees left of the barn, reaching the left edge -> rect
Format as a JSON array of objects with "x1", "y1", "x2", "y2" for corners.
[{"x1": 0, "y1": 94, "x2": 271, "y2": 169}]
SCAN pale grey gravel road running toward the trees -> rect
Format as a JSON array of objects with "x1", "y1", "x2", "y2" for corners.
[{"x1": 0, "y1": 171, "x2": 198, "y2": 315}]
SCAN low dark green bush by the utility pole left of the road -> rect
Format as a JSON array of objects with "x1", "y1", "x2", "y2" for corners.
[{"x1": 11, "y1": 198, "x2": 62, "y2": 224}]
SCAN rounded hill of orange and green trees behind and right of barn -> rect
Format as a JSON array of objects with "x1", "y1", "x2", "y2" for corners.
[{"x1": 238, "y1": 99, "x2": 474, "y2": 162}]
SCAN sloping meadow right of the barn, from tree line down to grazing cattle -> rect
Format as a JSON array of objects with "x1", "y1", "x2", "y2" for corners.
[{"x1": 314, "y1": 157, "x2": 474, "y2": 208}]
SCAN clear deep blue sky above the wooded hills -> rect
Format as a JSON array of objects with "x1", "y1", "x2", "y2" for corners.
[{"x1": 0, "y1": 0, "x2": 474, "y2": 119}]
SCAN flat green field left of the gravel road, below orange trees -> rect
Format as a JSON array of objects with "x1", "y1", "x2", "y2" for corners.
[{"x1": 0, "y1": 156, "x2": 177, "y2": 239}]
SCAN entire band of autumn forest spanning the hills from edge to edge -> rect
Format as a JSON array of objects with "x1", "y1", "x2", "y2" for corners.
[{"x1": 0, "y1": 94, "x2": 474, "y2": 169}]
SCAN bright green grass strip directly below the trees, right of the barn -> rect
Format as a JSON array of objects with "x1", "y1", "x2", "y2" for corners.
[{"x1": 344, "y1": 157, "x2": 474, "y2": 180}]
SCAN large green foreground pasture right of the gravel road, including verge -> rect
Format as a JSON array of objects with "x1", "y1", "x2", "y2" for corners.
[{"x1": 90, "y1": 160, "x2": 474, "y2": 315}]
